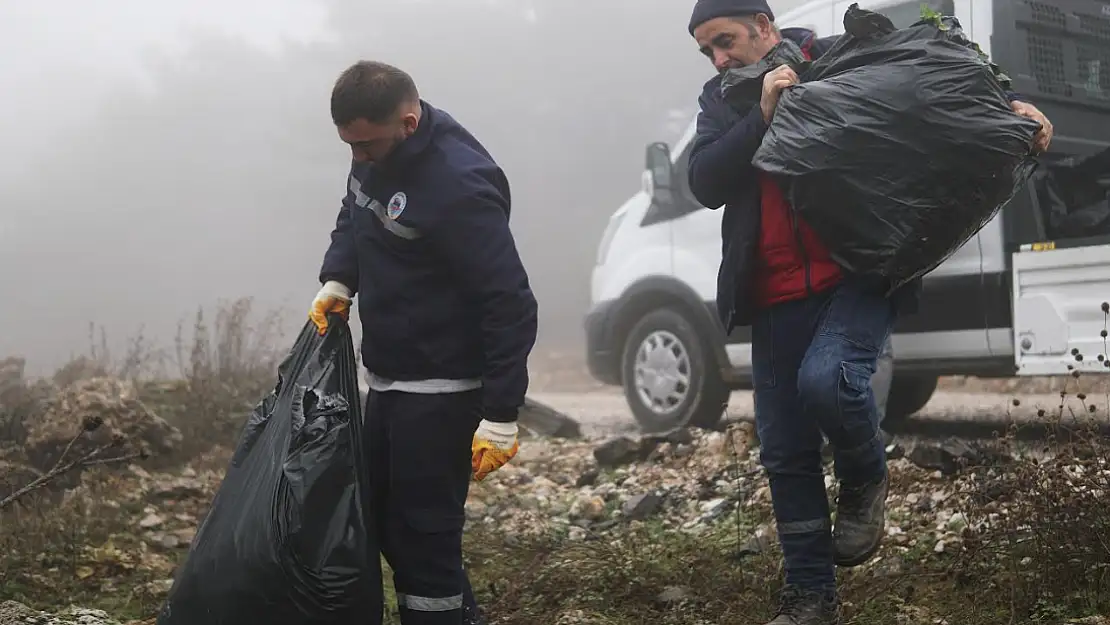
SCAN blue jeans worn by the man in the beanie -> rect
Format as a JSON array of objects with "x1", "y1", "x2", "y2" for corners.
[{"x1": 751, "y1": 276, "x2": 895, "y2": 592}]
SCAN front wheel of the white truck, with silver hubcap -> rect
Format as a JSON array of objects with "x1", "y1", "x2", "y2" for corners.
[{"x1": 620, "y1": 309, "x2": 729, "y2": 434}]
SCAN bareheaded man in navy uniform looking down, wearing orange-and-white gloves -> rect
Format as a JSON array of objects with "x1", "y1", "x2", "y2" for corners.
[{"x1": 310, "y1": 61, "x2": 537, "y2": 625}]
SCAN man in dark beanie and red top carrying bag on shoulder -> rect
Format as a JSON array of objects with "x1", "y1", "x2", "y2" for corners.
[{"x1": 688, "y1": 0, "x2": 1052, "y2": 625}]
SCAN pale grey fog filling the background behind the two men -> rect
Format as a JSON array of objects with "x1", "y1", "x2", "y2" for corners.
[{"x1": 0, "y1": 0, "x2": 800, "y2": 372}]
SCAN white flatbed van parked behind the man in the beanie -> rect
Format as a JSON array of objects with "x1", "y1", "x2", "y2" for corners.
[{"x1": 585, "y1": 0, "x2": 1110, "y2": 430}]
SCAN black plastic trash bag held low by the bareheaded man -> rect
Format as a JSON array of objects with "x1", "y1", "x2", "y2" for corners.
[{"x1": 158, "y1": 315, "x2": 382, "y2": 625}]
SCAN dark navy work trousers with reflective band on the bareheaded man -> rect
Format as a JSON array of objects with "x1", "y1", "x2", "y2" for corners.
[{"x1": 365, "y1": 390, "x2": 482, "y2": 625}]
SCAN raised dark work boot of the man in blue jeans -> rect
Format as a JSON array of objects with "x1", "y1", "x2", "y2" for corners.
[{"x1": 833, "y1": 475, "x2": 889, "y2": 567}]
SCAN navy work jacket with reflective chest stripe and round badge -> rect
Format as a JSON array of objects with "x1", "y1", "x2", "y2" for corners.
[{"x1": 320, "y1": 102, "x2": 537, "y2": 421}]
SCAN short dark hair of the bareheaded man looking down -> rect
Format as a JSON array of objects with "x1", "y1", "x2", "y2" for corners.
[{"x1": 332, "y1": 61, "x2": 420, "y2": 125}]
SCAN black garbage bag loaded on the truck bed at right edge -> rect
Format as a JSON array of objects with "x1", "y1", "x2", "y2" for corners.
[{"x1": 1030, "y1": 149, "x2": 1110, "y2": 239}]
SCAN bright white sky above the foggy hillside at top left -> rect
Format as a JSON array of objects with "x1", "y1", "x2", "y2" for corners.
[{"x1": 0, "y1": 0, "x2": 327, "y2": 173}]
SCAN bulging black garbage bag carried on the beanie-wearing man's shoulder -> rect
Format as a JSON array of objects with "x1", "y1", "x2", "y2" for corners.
[{"x1": 726, "y1": 4, "x2": 1040, "y2": 288}]
